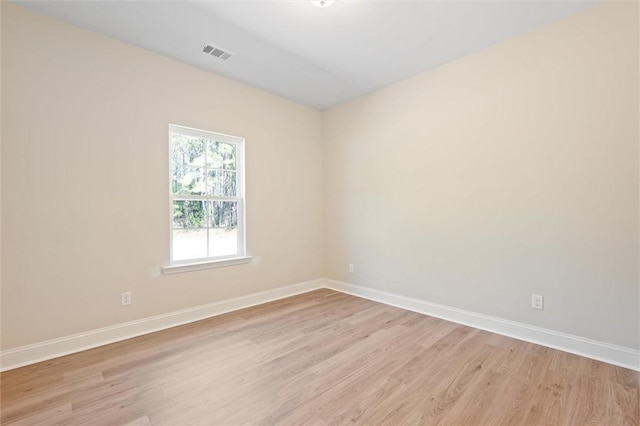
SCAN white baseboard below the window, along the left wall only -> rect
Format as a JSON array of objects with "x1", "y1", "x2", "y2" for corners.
[{"x1": 0, "y1": 279, "x2": 324, "y2": 371}]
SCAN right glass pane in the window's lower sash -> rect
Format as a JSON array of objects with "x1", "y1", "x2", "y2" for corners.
[{"x1": 209, "y1": 201, "x2": 238, "y2": 257}]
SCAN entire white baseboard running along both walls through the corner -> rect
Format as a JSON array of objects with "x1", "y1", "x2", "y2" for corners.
[{"x1": 0, "y1": 279, "x2": 640, "y2": 371}]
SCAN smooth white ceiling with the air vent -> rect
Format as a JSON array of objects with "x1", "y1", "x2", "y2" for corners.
[{"x1": 15, "y1": 0, "x2": 597, "y2": 109}]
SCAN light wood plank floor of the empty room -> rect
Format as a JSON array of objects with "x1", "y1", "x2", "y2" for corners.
[{"x1": 0, "y1": 290, "x2": 640, "y2": 425}]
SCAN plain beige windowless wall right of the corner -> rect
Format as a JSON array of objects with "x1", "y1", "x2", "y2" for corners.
[{"x1": 324, "y1": 3, "x2": 640, "y2": 348}]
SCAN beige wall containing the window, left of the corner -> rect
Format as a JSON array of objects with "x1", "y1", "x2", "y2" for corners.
[{"x1": 2, "y1": 2, "x2": 323, "y2": 349}]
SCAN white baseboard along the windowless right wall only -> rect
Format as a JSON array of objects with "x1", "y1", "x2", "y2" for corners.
[{"x1": 324, "y1": 280, "x2": 640, "y2": 371}]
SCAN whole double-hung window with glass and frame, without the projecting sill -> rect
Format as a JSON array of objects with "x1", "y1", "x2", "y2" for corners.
[{"x1": 169, "y1": 125, "x2": 245, "y2": 265}]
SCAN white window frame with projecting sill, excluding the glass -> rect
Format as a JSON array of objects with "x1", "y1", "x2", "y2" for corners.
[{"x1": 163, "y1": 124, "x2": 251, "y2": 274}]
